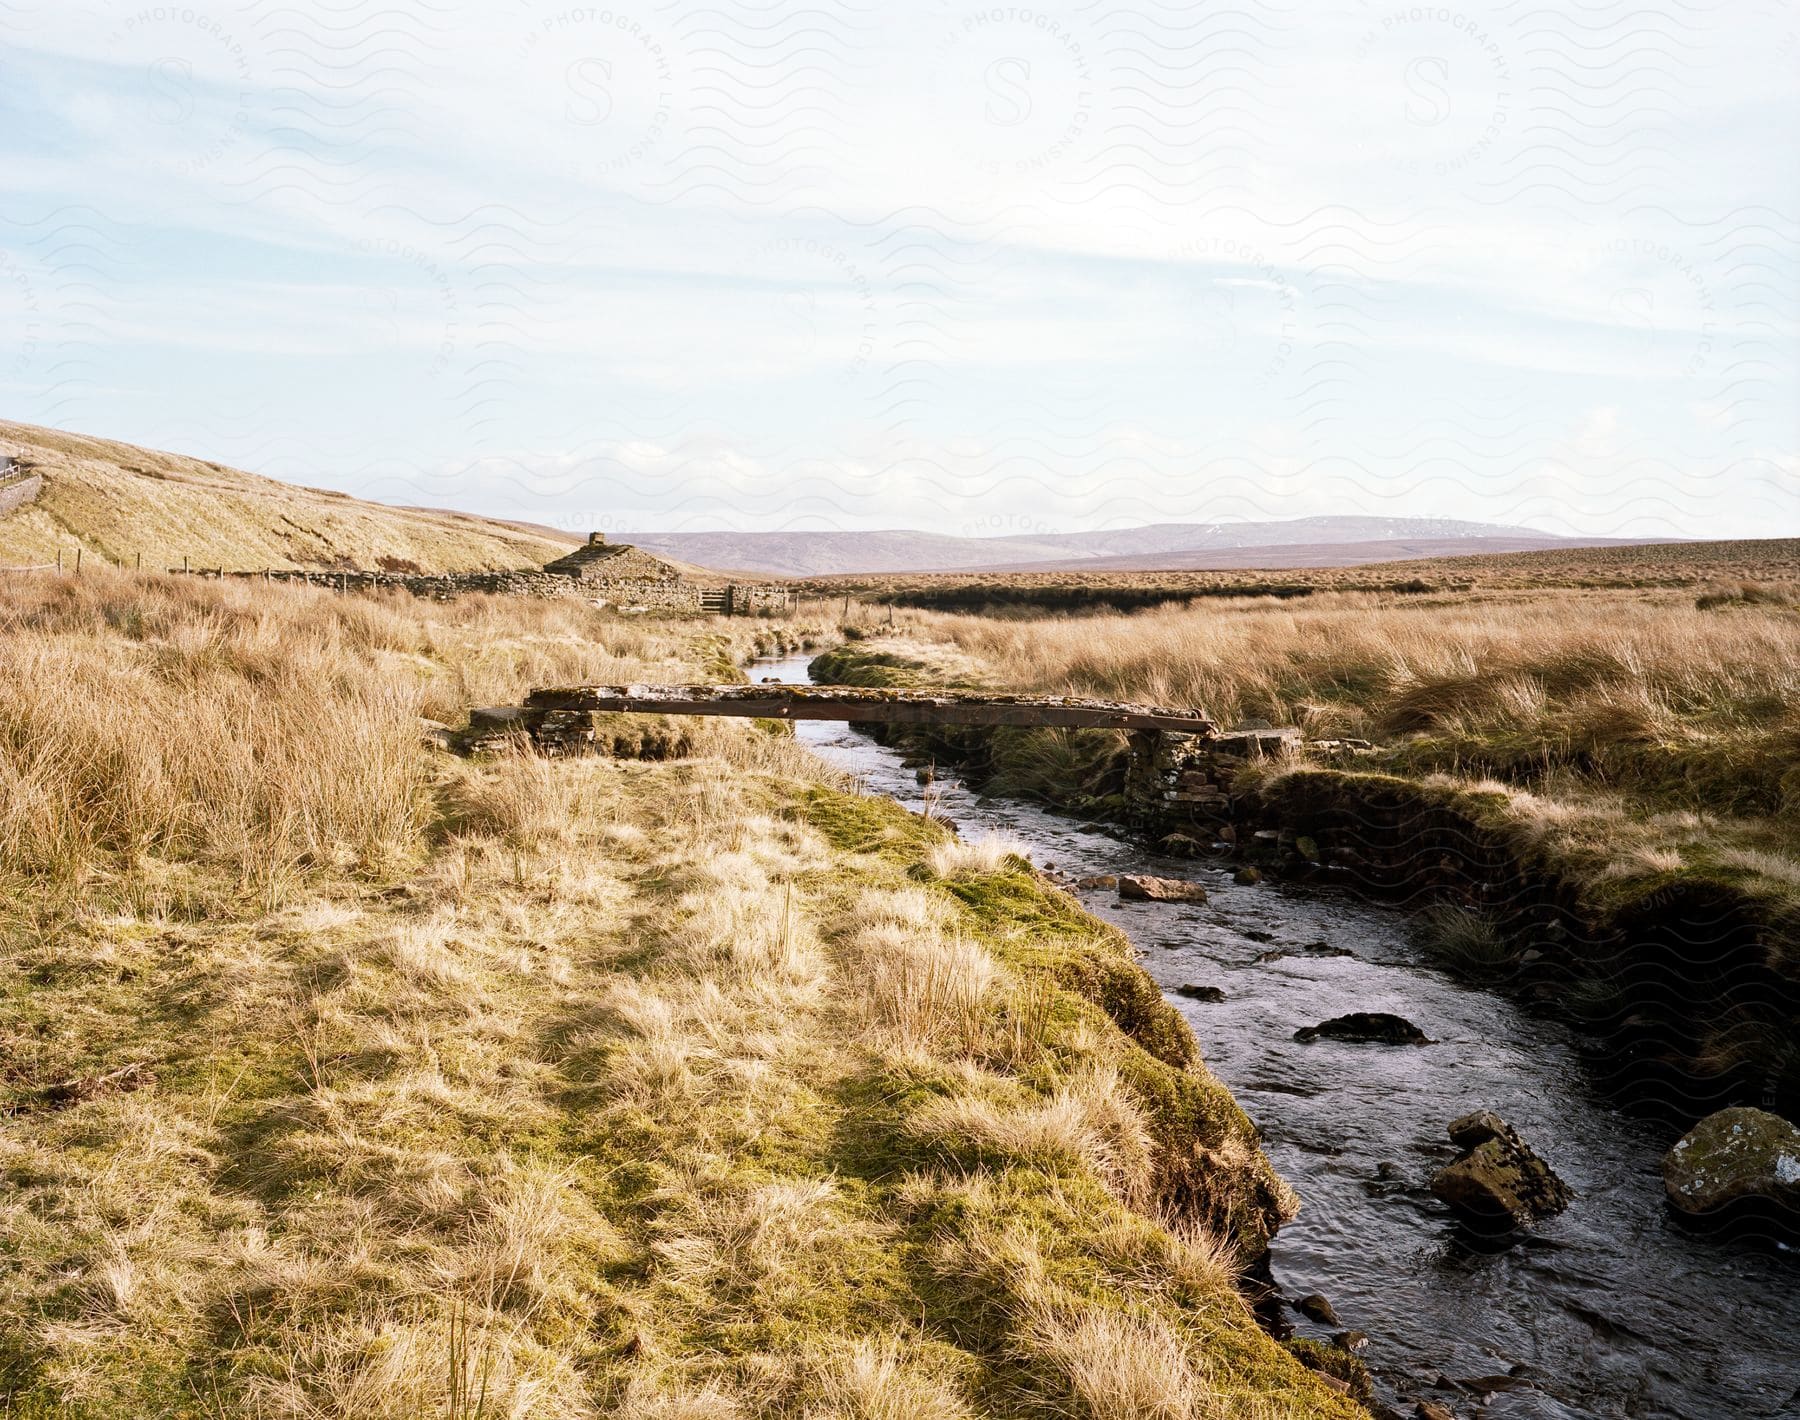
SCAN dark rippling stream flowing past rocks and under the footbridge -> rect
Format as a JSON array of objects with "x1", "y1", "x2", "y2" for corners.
[{"x1": 749, "y1": 657, "x2": 1800, "y2": 1420}]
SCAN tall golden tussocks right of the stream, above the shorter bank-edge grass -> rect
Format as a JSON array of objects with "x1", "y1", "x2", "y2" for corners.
[{"x1": 927, "y1": 592, "x2": 1800, "y2": 812}]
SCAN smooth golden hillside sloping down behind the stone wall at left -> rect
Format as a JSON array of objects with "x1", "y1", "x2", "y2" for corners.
[{"x1": 0, "y1": 421, "x2": 569, "y2": 572}]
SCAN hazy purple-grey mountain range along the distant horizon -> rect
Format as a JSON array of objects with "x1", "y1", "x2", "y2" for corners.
[{"x1": 619, "y1": 515, "x2": 1658, "y2": 578}]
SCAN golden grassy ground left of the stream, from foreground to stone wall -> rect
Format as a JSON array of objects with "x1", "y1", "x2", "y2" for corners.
[{"x1": 0, "y1": 572, "x2": 1361, "y2": 1420}]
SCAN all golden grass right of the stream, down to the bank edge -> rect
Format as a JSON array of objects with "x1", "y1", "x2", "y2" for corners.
[{"x1": 841, "y1": 583, "x2": 1800, "y2": 911}]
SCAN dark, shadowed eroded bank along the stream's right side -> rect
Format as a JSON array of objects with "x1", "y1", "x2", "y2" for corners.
[{"x1": 812, "y1": 644, "x2": 1800, "y2": 1123}]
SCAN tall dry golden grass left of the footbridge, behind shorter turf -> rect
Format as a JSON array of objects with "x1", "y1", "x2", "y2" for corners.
[{"x1": 0, "y1": 572, "x2": 795, "y2": 891}]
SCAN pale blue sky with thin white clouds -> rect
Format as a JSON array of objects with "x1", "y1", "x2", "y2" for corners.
[{"x1": 0, "y1": 0, "x2": 1800, "y2": 536}]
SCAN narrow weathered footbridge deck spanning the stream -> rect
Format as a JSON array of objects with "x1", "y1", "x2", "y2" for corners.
[{"x1": 511, "y1": 686, "x2": 1217, "y2": 736}]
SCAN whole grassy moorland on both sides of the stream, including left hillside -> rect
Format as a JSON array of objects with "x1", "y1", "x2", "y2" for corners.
[{"x1": 0, "y1": 425, "x2": 1800, "y2": 1420}]
